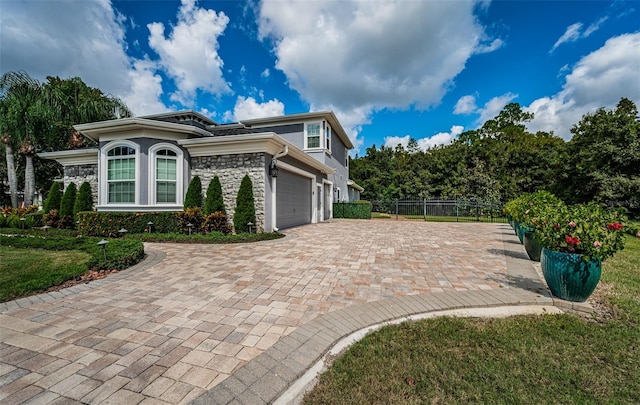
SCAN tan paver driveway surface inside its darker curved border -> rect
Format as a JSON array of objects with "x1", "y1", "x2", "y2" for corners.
[{"x1": 0, "y1": 220, "x2": 515, "y2": 404}]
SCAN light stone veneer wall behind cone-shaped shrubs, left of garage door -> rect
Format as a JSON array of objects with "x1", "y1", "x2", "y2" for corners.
[{"x1": 191, "y1": 153, "x2": 267, "y2": 231}]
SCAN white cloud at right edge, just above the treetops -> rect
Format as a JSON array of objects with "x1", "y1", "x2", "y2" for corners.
[{"x1": 525, "y1": 33, "x2": 640, "y2": 139}]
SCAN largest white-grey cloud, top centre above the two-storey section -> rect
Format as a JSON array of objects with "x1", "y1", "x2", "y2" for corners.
[{"x1": 258, "y1": 0, "x2": 502, "y2": 148}]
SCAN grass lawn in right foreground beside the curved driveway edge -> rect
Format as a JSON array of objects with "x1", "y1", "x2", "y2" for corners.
[{"x1": 304, "y1": 238, "x2": 640, "y2": 404}]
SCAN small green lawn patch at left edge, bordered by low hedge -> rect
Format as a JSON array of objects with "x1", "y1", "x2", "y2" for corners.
[{"x1": 0, "y1": 246, "x2": 91, "y2": 302}]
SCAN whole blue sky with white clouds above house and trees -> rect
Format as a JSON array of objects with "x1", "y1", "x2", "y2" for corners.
[{"x1": 0, "y1": 0, "x2": 640, "y2": 155}]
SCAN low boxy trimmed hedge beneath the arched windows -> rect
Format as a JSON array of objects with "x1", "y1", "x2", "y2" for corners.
[{"x1": 77, "y1": 211, "x2": 180, "y2": 237}]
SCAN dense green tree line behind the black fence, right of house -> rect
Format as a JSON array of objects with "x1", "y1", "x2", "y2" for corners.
[{"x1": 350, "y1": 98, "x2": 640, "y2": 216}]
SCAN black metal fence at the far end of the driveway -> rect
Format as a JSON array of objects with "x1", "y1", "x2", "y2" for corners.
[{"x1": 371, "y1": 198, "x2": 507, "y2": 222}]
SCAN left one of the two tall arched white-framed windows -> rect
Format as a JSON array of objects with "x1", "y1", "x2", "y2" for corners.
[{"x1": 107, "y1": 146, "x2": 136, "y2": 204}]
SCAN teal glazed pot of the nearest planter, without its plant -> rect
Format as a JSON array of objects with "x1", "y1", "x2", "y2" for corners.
[{"x1": 540, "y1": 248, "x2": 602, "y2": 302}]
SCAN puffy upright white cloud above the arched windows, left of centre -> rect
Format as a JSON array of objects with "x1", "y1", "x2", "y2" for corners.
[{"x1": 147, "y1": 0, "x2": 231, "y2": 105}]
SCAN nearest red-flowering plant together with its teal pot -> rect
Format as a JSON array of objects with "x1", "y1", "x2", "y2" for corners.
[{"x1": 534, "y1": 203, "x2": 626, "y2": 301}]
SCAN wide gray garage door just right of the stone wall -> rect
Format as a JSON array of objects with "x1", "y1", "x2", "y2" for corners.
[{"x1": 276, "y1": 170, "x2": 311, "y2": 229}]
